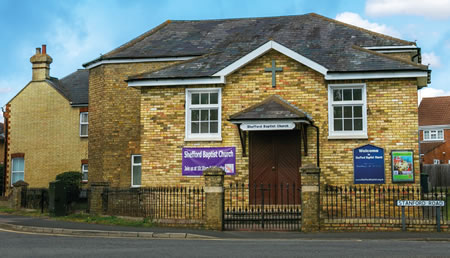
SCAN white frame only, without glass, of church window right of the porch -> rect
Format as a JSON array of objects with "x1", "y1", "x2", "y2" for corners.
[{"x1": 328, "y1": 83, "x2": 368, "y2": 139}]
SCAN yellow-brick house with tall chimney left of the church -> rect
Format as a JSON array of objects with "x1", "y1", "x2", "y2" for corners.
[{"x1": 4, "y1": 45, "x2": 89, "y2": 194}]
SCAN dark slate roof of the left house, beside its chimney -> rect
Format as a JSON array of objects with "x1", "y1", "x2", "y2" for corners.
[{"x1": 49, "y1": 69, "x2": 89, "y2": 105}]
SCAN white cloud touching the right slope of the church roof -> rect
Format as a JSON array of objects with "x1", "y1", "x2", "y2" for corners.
[{"x1": 335, "y1": 12, "x2": 400, "y2": 37}]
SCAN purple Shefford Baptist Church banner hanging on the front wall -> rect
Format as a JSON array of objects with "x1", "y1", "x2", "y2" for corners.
[{"x1": 182, "y1": 147, "x2": 236, "y2": 176}]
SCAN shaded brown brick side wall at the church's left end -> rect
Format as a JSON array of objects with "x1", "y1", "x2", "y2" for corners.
[{"x1": 89, "y1": 62, "x2": 178, "y2": 187}]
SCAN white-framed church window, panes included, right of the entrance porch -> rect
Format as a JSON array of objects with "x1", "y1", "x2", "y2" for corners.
[{"x1": 328, "y1": 83, "x2": 367, "y2": 139}]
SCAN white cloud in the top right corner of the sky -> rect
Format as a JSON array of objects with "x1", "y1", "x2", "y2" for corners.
[{"x1": 365, "y1": 0, "x2": 450, "y2": 19}]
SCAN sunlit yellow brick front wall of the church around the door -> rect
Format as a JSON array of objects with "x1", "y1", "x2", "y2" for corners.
[{"x1": 139, "y1": 51, "x2": 419, "y2": 186}]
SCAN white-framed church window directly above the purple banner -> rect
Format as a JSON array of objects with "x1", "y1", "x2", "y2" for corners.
[{"x1": 185, "y1": 88, "x2": 222, "y2": 141}]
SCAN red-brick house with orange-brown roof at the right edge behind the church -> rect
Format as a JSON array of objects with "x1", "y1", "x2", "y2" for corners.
[{"x1": 419, "y1": 96, "x2": 450, "y2": 164}]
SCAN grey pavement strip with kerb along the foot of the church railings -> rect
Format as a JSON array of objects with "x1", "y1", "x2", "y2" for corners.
[{"x1": 0, "y1": 214, "x2": 450, "y2": 242}]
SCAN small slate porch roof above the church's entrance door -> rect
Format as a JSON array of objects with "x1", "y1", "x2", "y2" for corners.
[{"x1": 228, "y1": 95, "x2": 312, "y2": 122}]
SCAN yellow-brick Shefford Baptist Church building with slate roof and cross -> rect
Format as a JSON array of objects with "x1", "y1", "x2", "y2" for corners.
[{"x1": 84, "y1": 14, "x2": 429, "y2": 194}]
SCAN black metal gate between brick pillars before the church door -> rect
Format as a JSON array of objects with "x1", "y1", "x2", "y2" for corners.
[{"x1": 223, "y1": 184, "x2": 302, "y2": 231}]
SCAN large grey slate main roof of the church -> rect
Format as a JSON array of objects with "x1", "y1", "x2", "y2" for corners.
[{"x1": 85, "y1": 14, "x2": 427, "y2": 80}]
